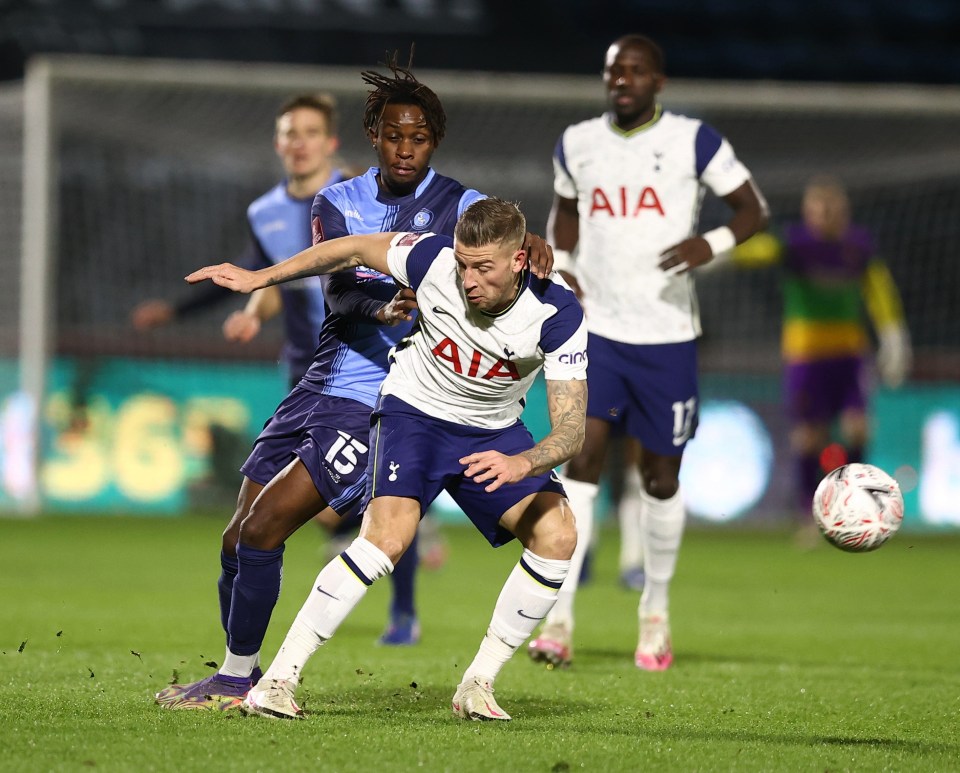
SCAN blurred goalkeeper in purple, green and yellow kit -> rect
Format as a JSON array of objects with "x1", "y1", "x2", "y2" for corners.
[{"x1": 735, "y1": 176, "x2": 911, "y2": 532}]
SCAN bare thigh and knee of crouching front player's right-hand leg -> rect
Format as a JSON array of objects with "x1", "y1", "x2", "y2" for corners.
[{"x1": 500, "y1": 491, "x2": 577, "y2": 561}]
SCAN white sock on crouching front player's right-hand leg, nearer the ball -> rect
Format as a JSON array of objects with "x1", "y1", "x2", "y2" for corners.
[{"x1": 463, "y1": 550, "x2": 570, "y2": 682}]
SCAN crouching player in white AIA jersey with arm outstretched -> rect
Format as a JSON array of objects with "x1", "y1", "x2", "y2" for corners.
[{"x1": 187, "y1": 198, "x2": 587, "y2": 721}]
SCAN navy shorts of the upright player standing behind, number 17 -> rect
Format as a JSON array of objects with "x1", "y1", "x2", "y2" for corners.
[{"x1": 587, "y1": 333, "x2": 700, "y2": 456}]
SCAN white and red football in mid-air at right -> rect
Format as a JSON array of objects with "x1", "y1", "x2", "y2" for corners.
[{"x1": 813, "y1": 464, "x2": 903, "y2": 553}]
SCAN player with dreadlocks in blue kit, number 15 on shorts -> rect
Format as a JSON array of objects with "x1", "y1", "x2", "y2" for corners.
[{"x1": 156, "y1": 51, "x2": 553, "y2": 718}]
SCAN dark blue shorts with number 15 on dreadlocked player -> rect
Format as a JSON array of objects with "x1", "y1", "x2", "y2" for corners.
[{"x1": 240, "y1": 387, "x2": 370, "y2": 517}]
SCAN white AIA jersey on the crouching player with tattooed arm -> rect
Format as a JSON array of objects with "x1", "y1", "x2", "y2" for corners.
[{"x1": 380, "y1": 233, "x2": 587, "y2": 429}]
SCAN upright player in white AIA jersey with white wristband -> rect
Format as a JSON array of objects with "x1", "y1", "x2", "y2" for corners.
[{"x1": 529, "y1": 35, "x2": 767, "y2": 671}]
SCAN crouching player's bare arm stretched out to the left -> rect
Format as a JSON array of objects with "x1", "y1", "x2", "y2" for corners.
[{"x1": 186, "y1": 233, "x2": 396, "y2": 293}]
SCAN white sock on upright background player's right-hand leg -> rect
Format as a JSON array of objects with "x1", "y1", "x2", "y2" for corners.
[{"x1": 640, "y1": 490, "x2": 686, "y2": 617}]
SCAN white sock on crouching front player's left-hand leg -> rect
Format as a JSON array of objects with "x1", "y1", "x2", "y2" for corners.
[{"x1": 263, "y1": 537, "x2": 393, "y2": 684}]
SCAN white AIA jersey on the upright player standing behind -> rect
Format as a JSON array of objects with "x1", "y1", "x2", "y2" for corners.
[{"x1": 553, "y1": 112, "x2": 750, "y2": 344}]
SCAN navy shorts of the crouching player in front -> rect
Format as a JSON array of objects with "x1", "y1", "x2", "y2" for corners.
[{"x1": 367, "y1": 395, "x2": 566, "y2": 547}]
